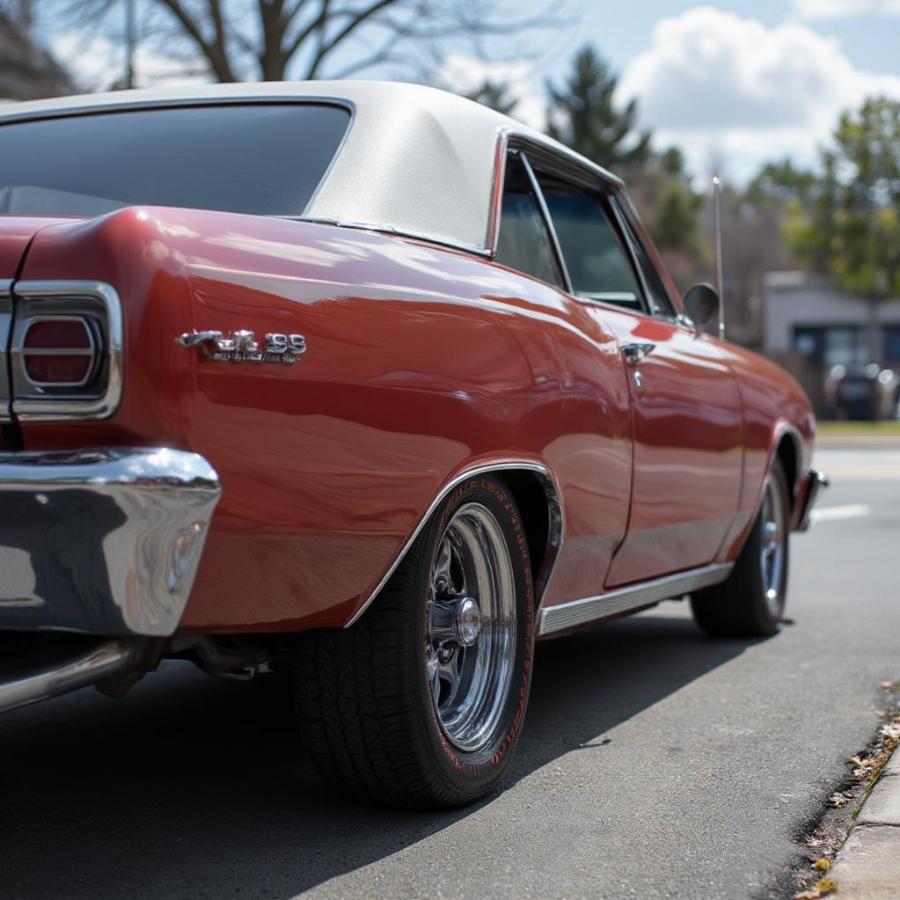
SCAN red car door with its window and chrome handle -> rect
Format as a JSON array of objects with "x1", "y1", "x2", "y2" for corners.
[{"x1": 537, "y1": 159, "x2": 742, "y2": 587}]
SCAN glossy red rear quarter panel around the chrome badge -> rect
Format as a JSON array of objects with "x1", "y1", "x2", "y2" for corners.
[{"x1": 15, "y1": 208, "x2": 631, "y2": 631}]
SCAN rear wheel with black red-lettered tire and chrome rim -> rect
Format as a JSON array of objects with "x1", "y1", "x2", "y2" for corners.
[{"x1": 293, "y1": 476, "x2": 534, "y2": 809}]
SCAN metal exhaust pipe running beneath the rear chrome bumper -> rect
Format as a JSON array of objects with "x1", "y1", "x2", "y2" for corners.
[{"x1": 0, "y1": 641, "x2": 135, "y2": 712}]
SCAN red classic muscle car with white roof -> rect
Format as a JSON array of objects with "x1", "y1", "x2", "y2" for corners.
[{"x1": 0, "y1": 82, "x2": 821, "y2": 807}]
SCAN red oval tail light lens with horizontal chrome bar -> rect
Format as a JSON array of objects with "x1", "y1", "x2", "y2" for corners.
[{"x1": 22, "y1": 316, "x2": 97, "y2": 387}]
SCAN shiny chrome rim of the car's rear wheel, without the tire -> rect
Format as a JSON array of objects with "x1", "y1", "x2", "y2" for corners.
[{"x1": 425, "y1": 503, "x2": 516, "y2": 752}]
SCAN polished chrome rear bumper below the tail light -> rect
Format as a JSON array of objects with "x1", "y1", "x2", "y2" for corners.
[{"x1": 0, "y1": 449, "x2": 221, "y2": 637}]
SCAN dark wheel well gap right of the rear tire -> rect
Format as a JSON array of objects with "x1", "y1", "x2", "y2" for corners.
[{"x1": 502, "y1": 469, "x2": 562, "y2": 604}]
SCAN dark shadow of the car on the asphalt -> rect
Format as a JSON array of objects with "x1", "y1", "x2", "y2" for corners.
[{"x1": 0, "y1": 616, "x2": 760, "y2": 900}]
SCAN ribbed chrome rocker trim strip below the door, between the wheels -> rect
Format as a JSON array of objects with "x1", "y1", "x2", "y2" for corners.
[{"x1": 537, "y1": 563, "x2": 733, "y2": 637}]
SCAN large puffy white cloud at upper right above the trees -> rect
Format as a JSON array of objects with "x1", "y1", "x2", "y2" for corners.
[{"x1": 619, "y1": 7, "x2": 900, "y2": 179}]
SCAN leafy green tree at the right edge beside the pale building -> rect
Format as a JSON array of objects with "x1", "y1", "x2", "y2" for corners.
[{"x1": 786, "y1": 97, "x2": 900, "y2": 300}]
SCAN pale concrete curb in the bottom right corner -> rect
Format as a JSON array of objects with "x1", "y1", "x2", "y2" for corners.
[{"x1": 829, "y1": 750, "x2": 900, "y2": 900}]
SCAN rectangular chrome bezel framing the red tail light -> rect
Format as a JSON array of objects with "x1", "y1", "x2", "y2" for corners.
[{"x1": 10, "y1": 280, "x2": 124, "y2": 422}]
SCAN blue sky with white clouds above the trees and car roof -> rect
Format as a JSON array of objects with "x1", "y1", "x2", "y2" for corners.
[{"x1": 54, "y1": 0, "x2": 900, "y2": 182}]
